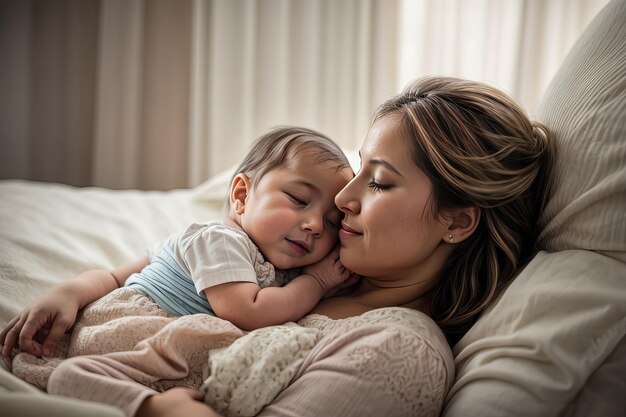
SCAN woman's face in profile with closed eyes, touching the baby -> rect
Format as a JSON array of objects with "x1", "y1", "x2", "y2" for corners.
[{"x1": 335, "y1": 114, "x2": 450, "y2": 286}]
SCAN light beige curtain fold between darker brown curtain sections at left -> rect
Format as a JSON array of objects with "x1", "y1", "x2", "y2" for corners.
[{"x1": 90, "y1": 0, "x2": 144, "y2": 188}]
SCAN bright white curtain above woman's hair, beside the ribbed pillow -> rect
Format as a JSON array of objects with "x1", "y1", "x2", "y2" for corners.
[{"x1": 396, "y1": 0, "x2": 607, "y2": 113}]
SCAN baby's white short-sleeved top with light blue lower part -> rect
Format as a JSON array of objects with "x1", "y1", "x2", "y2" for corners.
[{"x1": 125, "y1": 222, "x2": 299, "y2": 315}]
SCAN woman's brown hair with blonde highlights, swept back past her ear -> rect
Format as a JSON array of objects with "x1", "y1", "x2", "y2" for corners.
[{"x1": 374, "y1": 77, "x2": 555, "y2": 344}]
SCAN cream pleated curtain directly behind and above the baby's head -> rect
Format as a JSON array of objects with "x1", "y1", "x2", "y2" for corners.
[{"x1": 189, "y1": 0, "x2": 398, "y2": 183}]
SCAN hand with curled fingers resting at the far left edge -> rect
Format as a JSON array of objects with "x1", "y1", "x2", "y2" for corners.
[{"x1": 0, "y1": 290, "x2": 80, "y2": 358}]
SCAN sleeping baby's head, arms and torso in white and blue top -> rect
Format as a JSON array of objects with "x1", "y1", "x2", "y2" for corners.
[{"x1": 0, "y1": 127, "x2": 356, "y2": 357}]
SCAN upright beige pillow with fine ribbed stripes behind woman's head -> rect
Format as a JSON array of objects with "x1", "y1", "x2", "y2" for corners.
[{"x1": 536, "y1": 0, "x2": 626, "y2": 260}]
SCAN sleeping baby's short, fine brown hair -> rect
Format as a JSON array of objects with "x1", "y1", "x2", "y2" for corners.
[{"x1": 231, "y1": 126, "x2": 350, "y2": 191}]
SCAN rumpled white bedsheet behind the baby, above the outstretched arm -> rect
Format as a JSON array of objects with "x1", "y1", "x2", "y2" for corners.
[{"x1": 0, "y1": 180, "x2": 223, "y2": 325}]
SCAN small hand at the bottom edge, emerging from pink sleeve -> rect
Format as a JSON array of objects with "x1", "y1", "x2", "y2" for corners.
[{"x1": 135, "y1": 388, "x2": 219, "y2": 417}]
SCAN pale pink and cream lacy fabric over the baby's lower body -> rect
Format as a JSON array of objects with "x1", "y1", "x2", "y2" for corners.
[{"x1": 11, "y1": 288, "x2": 319, "y2": 416}]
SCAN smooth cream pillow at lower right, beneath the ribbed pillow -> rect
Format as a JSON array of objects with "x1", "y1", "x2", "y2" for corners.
[{"x1": 443, "y1": 250, "x2": 626, "y2": 417}]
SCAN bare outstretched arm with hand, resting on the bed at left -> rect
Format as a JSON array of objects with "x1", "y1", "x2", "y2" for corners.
[{"x1": 0, "y1": 257, "x2": 148, "y2": 358}]
